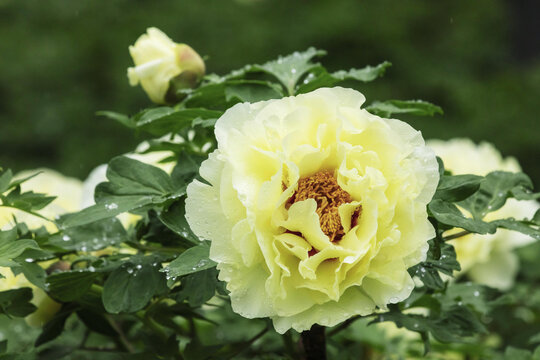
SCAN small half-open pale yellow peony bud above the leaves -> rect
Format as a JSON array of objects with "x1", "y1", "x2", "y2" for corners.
[{"x1": 128, "y1": 28, "x2": 205, "y2": 104}]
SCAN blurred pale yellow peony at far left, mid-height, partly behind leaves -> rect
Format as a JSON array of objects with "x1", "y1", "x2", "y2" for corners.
[{"x1": 0, "y1": 169, "x2": 82, "y2": 232}]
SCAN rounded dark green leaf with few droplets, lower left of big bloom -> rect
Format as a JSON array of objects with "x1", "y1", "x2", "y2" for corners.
[{"x1": 102, "y1": 256, "x2": 167, "y2": 314}]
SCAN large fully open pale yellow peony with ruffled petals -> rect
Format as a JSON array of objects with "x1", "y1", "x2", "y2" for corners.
[{"x1": 186, "y1": 87, "x2": 439, "y2": 333}]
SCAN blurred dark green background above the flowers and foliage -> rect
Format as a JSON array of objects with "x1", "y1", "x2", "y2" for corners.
[{"x1": 0, "y1": 0, "x2": 540, "y2": 186}]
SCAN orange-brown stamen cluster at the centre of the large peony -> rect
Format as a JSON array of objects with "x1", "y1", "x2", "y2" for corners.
[{"x1": 286, "y1": 170, "x2": 360, "y2": 241}]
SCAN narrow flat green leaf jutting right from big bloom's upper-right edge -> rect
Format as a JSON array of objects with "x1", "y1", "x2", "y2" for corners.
[{"x1": 366, "y1": 100, "x2": 443, "y2": 117}]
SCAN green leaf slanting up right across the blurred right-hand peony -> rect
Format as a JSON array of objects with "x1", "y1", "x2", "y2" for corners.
[{"x1": 458, "y1": 171, "x2": 532, "y2": 219}]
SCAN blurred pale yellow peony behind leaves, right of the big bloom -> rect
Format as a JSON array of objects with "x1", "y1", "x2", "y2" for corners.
[{"x1": 428, "y1": 139, "x2": 539, "y2": 290}]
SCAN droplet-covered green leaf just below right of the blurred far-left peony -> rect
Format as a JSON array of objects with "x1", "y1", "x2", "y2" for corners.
[{"x1": 49, "y1": 218, "x2": 127, "y2": 251}]
